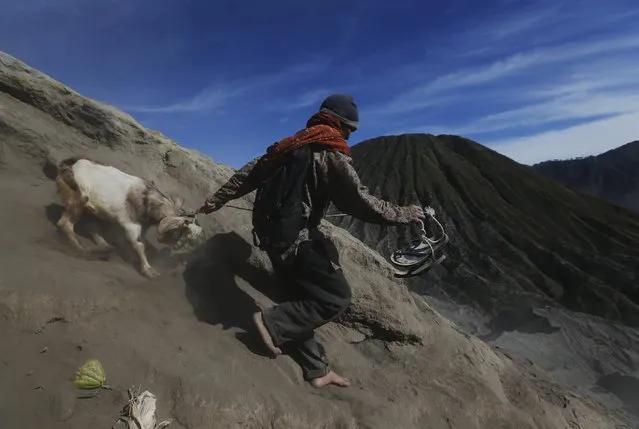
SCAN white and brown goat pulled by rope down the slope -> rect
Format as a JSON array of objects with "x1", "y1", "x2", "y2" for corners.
[{"x1": 56, "y1": 156, "x2": 204, "y2": 278}]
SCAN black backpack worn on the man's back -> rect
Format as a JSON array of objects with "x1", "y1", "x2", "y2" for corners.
[{"x1": 253, "y1": 145, "x2": 313, "y2": 253}]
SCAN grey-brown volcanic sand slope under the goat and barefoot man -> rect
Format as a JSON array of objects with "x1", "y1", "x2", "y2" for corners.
[{"x1": 0, "y1": 54, "x2": 631, "y2": 429}]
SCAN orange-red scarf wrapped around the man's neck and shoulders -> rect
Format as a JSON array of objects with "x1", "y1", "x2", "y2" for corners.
[{"x1": 253, "y1": 112, "x2": 351, "y2": 179}]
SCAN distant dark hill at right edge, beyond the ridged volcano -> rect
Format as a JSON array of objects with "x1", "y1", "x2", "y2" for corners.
[{"x1": 533, "y1": 140, "x2": 639, "y2": 212}]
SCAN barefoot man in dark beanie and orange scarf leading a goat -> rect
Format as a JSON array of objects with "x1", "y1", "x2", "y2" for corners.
[{"x1": 200, "y1": 94, "x2": 425, "y2": 388}]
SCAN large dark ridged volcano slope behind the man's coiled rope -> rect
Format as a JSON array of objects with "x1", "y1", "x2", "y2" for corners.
[{"x1": 333, "y1": 134, "x2": 639, "y2": 326}]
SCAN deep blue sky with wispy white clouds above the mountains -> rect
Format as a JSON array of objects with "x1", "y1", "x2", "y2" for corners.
[{"x1": 0, "y1": 0, "x2": 639, "y2": 168}]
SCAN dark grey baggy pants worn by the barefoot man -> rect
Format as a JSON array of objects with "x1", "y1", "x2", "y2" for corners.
[{"x1": 262, "y1": 239, "x2": 351, "y2": 380}]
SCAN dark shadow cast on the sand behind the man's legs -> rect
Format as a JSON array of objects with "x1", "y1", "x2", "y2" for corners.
[{"x1": 183, "y1": 232, "x2": 288, "y2": 356}]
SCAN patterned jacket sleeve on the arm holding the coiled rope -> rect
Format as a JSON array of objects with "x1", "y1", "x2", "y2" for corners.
[{"x1": 326, "y1": 152, "x2": 411, "y2": 225}]
